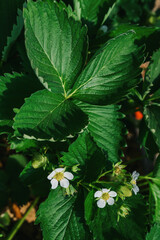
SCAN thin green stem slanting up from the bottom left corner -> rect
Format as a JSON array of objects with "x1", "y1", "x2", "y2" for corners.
[{"x1": 6, "y1": 197, "x2": 39, "y2": 240}]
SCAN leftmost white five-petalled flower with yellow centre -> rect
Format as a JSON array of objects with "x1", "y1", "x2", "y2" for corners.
[{"x1": 47, "y1": 168, "x2": 74, "y2": 189}]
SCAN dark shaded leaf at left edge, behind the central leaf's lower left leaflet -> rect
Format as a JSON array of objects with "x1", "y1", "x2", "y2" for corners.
[{"x1": 0, "y1": 73, "x2": 42, "y2": 121}]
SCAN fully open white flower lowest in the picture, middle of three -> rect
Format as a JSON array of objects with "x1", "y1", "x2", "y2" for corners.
[{"x1": 94, "y1": 188, "x2": 117, "y2": 208}]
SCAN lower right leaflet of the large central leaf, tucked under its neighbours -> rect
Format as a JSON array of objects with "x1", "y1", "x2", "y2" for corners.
[{"x1": 75, "y1": 101, "x2": 124, "y2": 162}]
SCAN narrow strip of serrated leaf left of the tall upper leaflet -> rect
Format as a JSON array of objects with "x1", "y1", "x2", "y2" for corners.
[{"x1": 2, "y1": 9, "x2": 23, "y2": 62}]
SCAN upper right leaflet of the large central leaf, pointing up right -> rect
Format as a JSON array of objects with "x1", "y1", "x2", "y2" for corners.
[{"x1": 70, "y1": 31, "x2": 143, "y2": 105}]
